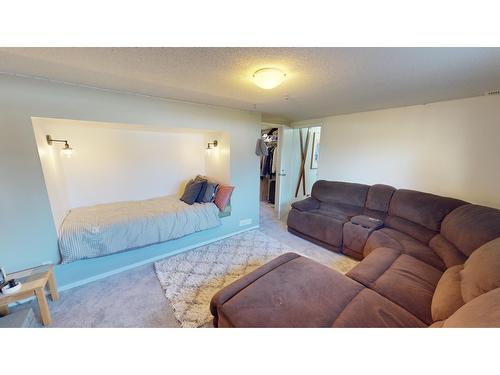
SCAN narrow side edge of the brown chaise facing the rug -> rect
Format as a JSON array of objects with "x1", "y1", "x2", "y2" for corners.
[{"x1": 210, "y1": 253, "x2": 300, "y2": 326}]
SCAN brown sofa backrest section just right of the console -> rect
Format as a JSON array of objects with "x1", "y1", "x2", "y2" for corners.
[{"x1": 385, "y1": 189, "x2": 466, "y2": 243}]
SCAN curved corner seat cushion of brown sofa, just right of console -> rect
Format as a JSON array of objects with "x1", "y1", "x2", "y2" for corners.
[{"x1": 363, "y1": 228, "x2": 446, "y2": 271}]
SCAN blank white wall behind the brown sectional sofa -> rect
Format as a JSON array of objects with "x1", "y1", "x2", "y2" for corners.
[{"x1": 293, "y1": 97, "x2": 500, "y2": 208}]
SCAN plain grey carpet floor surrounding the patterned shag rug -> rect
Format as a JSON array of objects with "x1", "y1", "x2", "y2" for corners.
[{"x1": 12, "y1": 204, "x2": 356, "y2": 327}]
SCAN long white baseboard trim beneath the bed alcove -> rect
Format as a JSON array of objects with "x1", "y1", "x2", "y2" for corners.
[{"x1": 58, "y1": 225, "x2": 259, "y2": 291}]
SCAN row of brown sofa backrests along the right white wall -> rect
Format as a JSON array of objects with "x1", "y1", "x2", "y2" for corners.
[{"x1": 311, "y1": 180, "x2": 500, "y2": 258}]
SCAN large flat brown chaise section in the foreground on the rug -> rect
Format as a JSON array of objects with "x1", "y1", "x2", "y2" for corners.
[{"x1": 210, "y1": 253, "x2": 425, "y2": 327}]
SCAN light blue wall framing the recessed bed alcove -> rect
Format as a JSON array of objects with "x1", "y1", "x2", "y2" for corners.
[{"x1": 0, "y1": 74, "x2": 261, "y2": 287}]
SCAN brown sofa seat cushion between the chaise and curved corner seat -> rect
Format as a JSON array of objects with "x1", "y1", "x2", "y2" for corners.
[{"x1": 347, "y1": 248, "x2": 442, "y2": 324}]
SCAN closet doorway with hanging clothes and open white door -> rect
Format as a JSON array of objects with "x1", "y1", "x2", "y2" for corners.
[{"x1": 260, "y1": 124, "x2": 294, "y2": 218}]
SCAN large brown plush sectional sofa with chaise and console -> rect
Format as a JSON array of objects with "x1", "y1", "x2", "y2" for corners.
[{"x1": 210, "y1": 181, "x2": 500, "y2": 327}]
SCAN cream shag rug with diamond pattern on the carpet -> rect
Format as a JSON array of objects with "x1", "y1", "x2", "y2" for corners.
[{"x1": 155, "y1": 229, "x2": 357, "y2": 328}]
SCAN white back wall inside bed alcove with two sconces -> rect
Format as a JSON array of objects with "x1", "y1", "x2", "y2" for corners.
[{"x1": 32, "y1": 118, "x2": 229, "y2": 228}]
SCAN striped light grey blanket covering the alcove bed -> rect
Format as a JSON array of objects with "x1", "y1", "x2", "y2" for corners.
[{"x1": 59, "y1": 195, "x2": 220, "y2": 263}]
